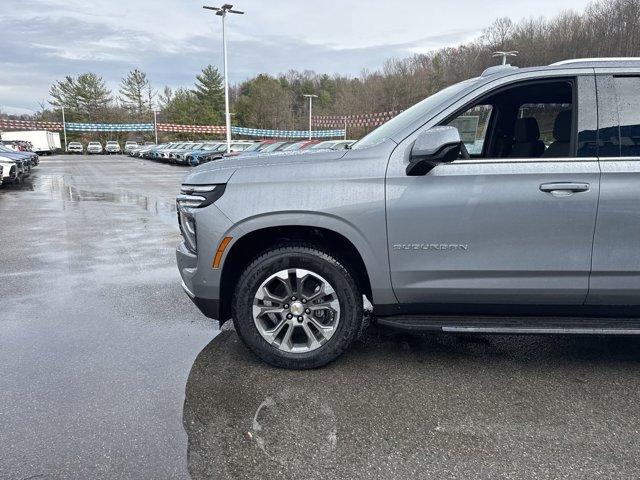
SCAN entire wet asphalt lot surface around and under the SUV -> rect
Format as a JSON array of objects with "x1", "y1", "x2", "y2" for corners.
[{"x1": 0, "y1": 155, "x2": 640, "y2": 480}]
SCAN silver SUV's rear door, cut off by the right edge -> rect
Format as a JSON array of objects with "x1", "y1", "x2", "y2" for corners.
[{"x1": 587, "y1": 68, "x2": 640, "y2": 305}]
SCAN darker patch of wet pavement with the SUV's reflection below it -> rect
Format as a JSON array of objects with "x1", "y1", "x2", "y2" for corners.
[{"x1": 184, "y1": 327, "x2": 640, "y2": 479}]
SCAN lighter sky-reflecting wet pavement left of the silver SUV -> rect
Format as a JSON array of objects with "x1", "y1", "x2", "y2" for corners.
[{"x1": 0, "y1": 155, "x2": 216, "y2": 480}]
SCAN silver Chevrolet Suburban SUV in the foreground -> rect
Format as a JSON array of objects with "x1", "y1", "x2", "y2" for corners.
[{"x1": 177, "y1": 59, "x2": 640, "y2": 368}]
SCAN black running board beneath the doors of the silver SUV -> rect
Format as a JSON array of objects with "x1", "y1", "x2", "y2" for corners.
[{"x1": 377, "y1": 315, "x2": 640, "y2": 335}]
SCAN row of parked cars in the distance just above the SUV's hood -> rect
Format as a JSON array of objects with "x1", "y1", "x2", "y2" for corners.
[{"x1": 125, "y1": 140, "x2": 354, "y2": 166}]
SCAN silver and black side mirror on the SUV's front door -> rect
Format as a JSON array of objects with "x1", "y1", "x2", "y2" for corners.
[{"x1": 407, "y1": 126, "x2": 462, "y2": 176}]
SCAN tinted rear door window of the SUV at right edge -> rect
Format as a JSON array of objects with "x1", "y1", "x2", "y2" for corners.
[{"x1": 614, "y1": 77, "x2": 640, "y2": 157}]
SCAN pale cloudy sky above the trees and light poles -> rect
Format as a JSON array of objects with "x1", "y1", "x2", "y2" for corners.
[{"x1": 0, "y1": 0, "x2": 588, "y2": 113}]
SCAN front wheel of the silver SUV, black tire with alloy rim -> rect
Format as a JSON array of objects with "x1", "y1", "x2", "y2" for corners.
[{"x1": 232, "y1": 244, "x2": 363, "y2": 370}]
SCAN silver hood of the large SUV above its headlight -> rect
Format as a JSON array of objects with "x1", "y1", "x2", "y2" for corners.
[{"x1": 184, "y1": 150, "x2": 349, "y2": 185}]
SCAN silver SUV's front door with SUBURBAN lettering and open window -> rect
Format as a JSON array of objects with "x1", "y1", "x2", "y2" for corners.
[{"x1": 387, "y1": 76, "x2": 600, "y2": 305}]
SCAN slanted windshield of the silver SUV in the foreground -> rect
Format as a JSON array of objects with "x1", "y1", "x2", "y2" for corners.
[{"x1": 351, "y1": 79, "x2": 476, "y2": 149}]
